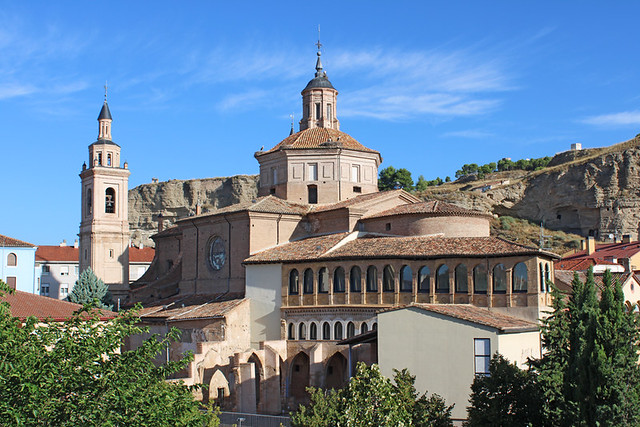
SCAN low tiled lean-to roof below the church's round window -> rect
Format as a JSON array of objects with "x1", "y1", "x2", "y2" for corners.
[{"x1": 140, "y1": 294, "x2": 245, "y2": 321}]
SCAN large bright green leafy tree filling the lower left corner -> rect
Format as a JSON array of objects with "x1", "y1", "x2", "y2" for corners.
[{"x1": 0, "y1": 281, "x2": 218, "y2": 427}]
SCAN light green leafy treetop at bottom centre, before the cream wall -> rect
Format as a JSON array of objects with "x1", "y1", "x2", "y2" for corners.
[{"x1": 291, "y1": 363, "x2": 453, "y2": 427}]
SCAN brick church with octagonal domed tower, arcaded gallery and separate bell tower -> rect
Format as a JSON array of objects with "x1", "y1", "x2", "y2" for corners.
[{"x1": 80, "y1": 45, "x2": 558, "y2": 420}]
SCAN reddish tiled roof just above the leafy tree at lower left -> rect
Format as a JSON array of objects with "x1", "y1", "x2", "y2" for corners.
[{"x1": 0, "y1": 291, "x2": 117, "y2": 322}]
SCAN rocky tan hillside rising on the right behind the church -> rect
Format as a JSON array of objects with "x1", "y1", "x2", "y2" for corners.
[{"x1": 422, "y1": 137, "x2": 640, "y2": 240}]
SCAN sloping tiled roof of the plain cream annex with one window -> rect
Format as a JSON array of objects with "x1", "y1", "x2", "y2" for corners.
[{"x1": 384, "y1": 303, "x2": 538, "y2": 332}]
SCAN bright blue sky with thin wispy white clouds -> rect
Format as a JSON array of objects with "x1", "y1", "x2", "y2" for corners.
[{"x1": 0, "y1": 0, "x2": 640, "y2": 245}]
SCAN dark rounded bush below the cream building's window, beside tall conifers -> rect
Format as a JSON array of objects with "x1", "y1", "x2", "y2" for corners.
[{"x1": 465, "y1": 354, "x2": 544, "y2": 427}]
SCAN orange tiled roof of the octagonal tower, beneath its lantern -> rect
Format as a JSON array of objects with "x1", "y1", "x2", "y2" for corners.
[{"x1": 256, "y1": 127, "x2": 379, "y2": 156}]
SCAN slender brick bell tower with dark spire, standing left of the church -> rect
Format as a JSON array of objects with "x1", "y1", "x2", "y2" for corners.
[{"x1": 79, "y1": 90, "x2": 130, "y2": 301}]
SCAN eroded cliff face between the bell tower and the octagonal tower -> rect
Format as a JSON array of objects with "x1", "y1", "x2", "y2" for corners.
[{"x1": 129, "y1": 175, "x2": 258, "y2": 246}]
